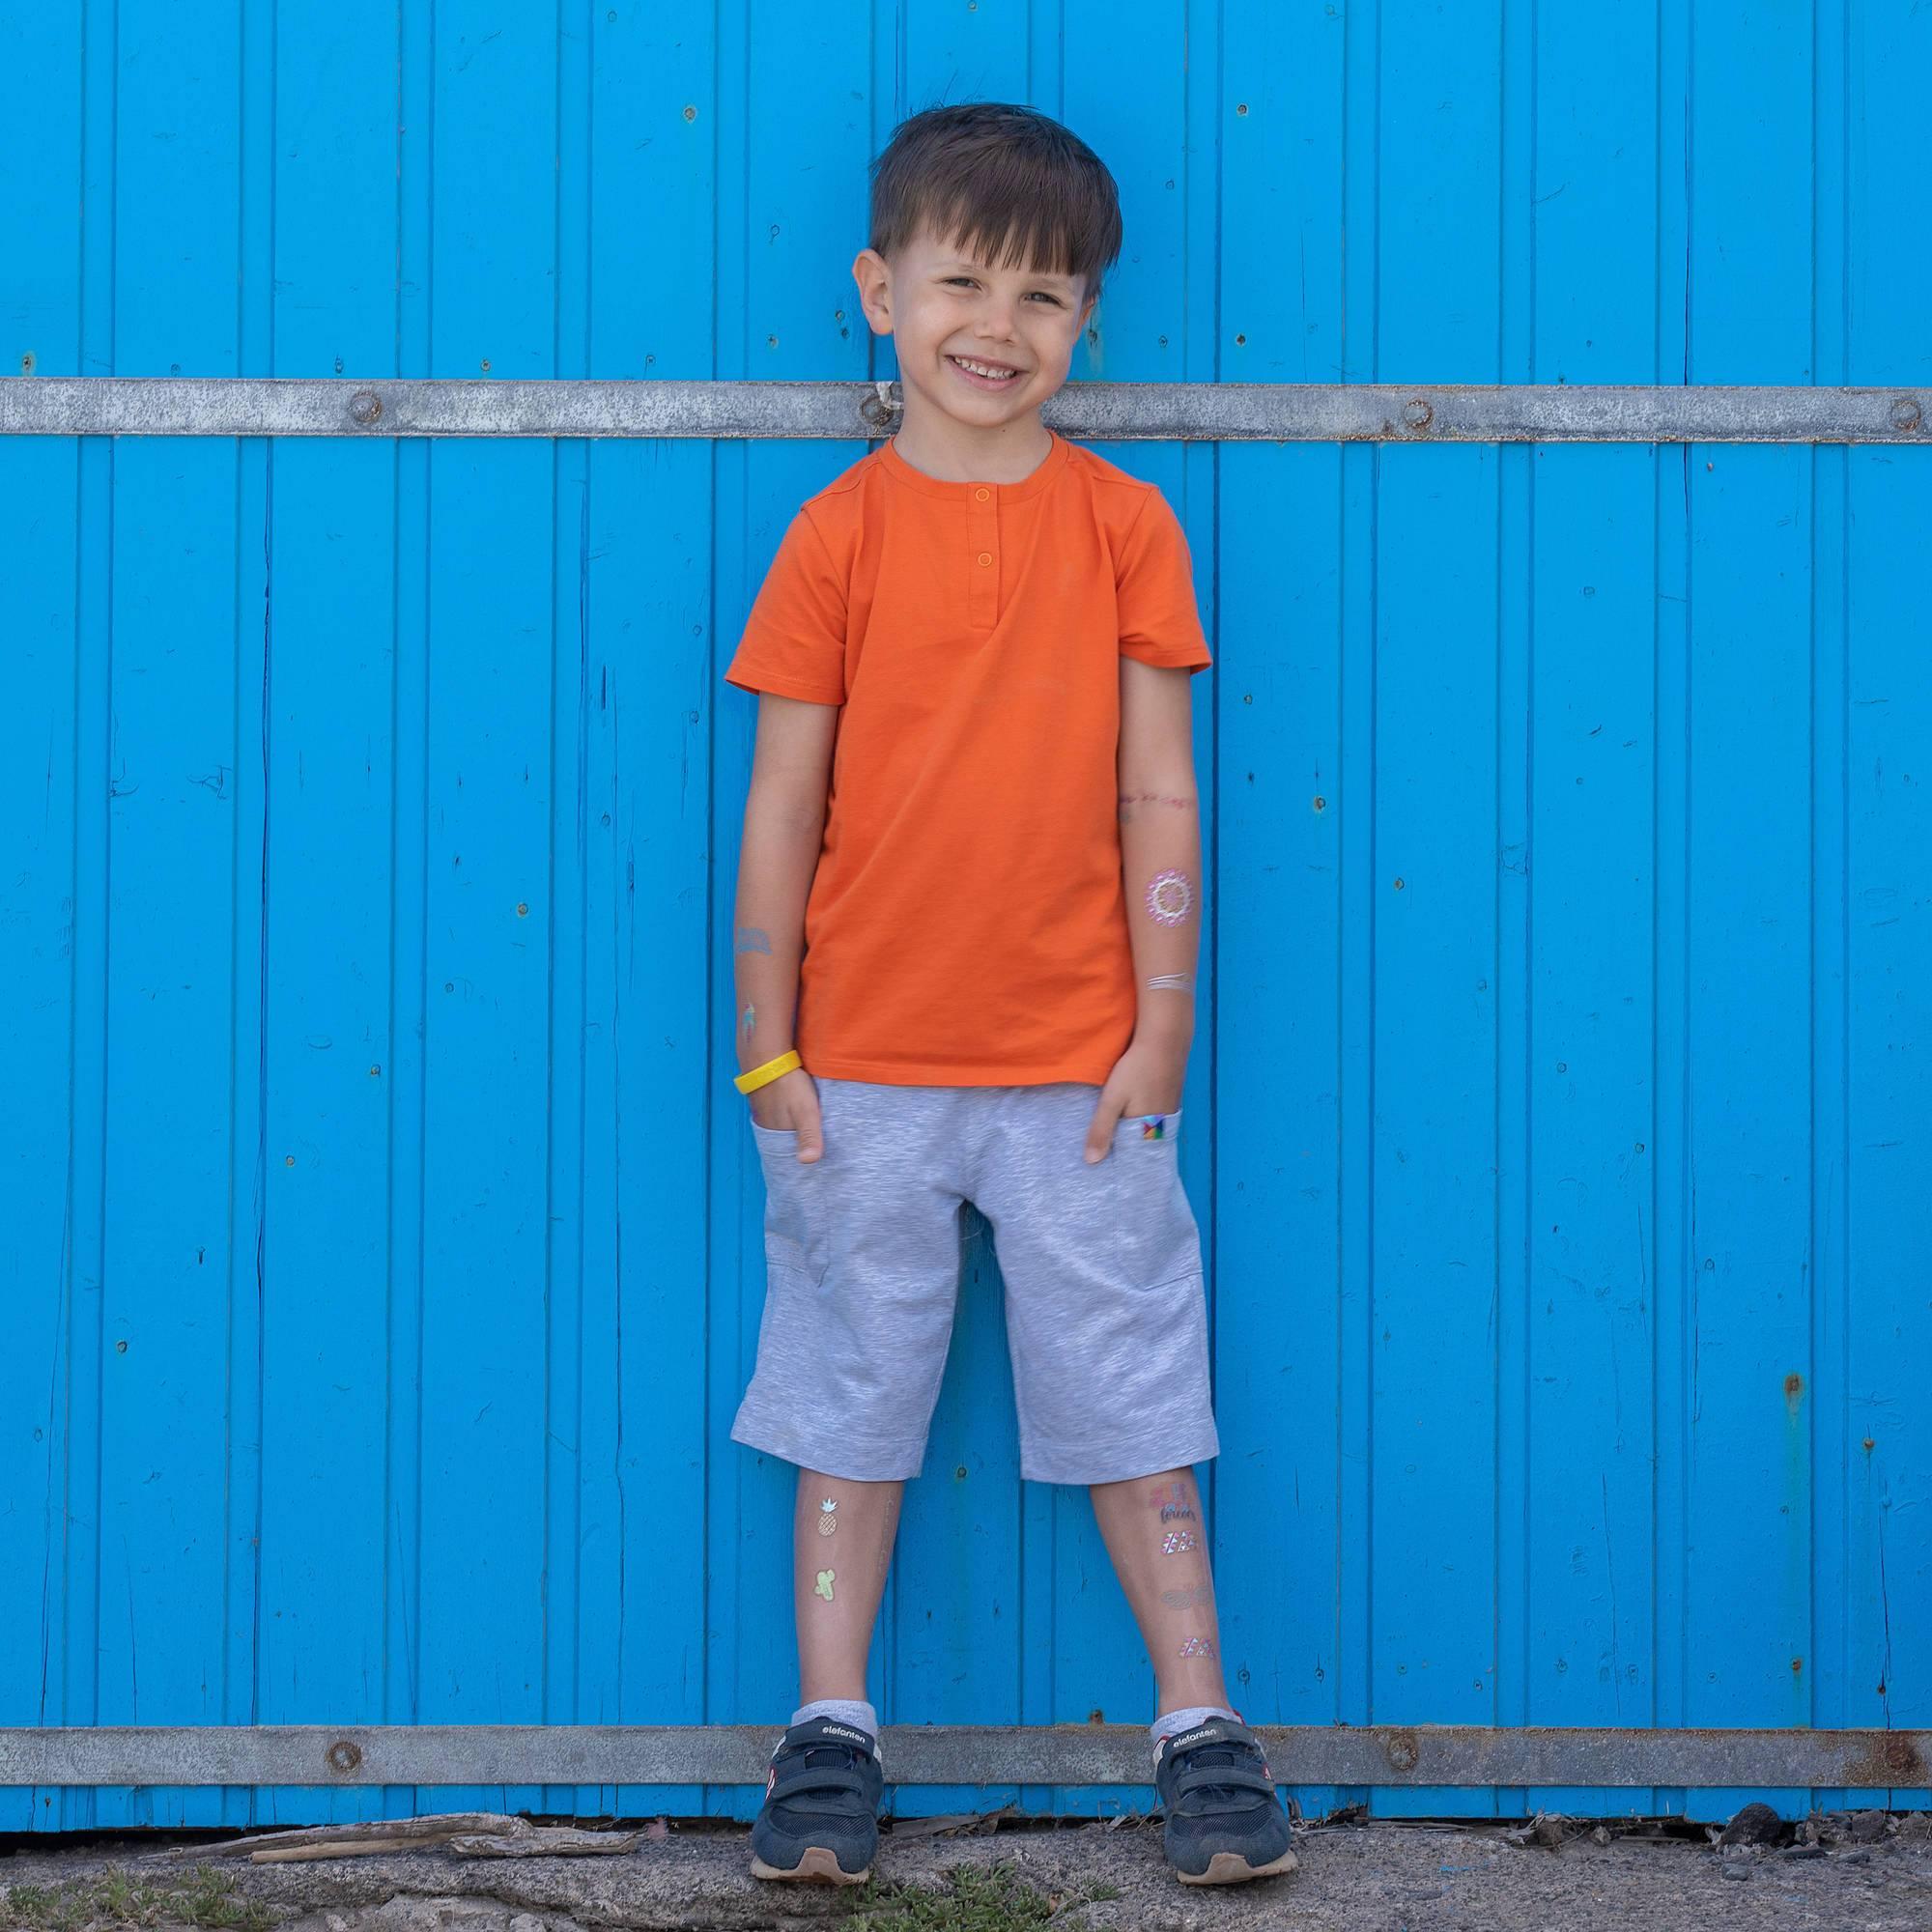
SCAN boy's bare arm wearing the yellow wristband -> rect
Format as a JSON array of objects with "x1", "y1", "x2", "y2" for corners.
[{"x1": 732, "y1": 692, "x2": 838, "y2": 1121}]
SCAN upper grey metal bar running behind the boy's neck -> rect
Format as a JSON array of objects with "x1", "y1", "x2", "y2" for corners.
[{"x1": 0, "y1": 377, "x2": 1932, "y2": 442}]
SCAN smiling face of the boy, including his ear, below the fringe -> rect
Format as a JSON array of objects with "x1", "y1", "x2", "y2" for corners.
[{"x1": 852, "y1": 232, "x2": 1095, "y2": 429}]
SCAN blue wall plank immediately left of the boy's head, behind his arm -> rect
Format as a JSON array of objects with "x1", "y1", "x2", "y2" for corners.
[{"x1": 705, "y1": 0, "x2": 885, "y2": 1818}]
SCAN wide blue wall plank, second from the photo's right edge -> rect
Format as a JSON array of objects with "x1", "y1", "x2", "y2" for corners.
[{"x1": 1683, "y1": 0, "x2": 1814, "y2": 1818}]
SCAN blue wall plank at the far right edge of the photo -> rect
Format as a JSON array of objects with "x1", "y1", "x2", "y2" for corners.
[{"x1": 1837, "y1": 8, "x2": 1932, "y2": 1808}]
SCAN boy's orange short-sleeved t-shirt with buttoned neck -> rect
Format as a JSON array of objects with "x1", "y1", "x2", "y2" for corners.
[{"x1": 724, "y1": 431, "x2": 1213, "y2": 1086}]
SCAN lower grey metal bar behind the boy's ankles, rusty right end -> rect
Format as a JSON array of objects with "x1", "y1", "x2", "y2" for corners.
[{"x1": 0, "y1": 1723, "x2": 1932, "y2": 1789}]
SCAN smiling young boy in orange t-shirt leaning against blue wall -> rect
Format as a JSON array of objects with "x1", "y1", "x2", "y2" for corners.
[{"x1": 724, "y1": 102, "x2": 1294, "y2": 1884}]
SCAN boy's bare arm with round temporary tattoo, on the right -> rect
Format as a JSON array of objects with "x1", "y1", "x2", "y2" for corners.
[{"x1": 1119, "y1": 657, "x2": 1202, "y2": 1113}]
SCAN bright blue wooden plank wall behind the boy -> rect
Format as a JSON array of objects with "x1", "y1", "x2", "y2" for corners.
[{"x1": 0, "y1": 0, "x2": 1932, "y2": 1830}]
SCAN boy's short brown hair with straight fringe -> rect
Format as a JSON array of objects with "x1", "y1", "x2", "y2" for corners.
[{"x1": 871, "y1": 100, "x2": 1121, "y2": 296}]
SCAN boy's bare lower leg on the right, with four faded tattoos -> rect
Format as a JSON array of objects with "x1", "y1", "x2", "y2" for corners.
[{"x1": 1092, "y1": 1468, "x2": 1231, "y2": 1716}]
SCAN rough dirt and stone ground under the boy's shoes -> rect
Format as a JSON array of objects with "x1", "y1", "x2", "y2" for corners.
[{"x1": 0, "y1": 1812, "x2": 1932, "y2": 1932}]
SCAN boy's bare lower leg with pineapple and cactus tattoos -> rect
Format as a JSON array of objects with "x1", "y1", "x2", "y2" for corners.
[{"x1": 792, "y1": 1468, "x2": 906, "y2": 1704}]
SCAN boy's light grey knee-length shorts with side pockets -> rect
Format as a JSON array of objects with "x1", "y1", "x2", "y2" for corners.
[{"x1": 732, "y1": 1074, "x2": 1221, "y2": 1484}]
